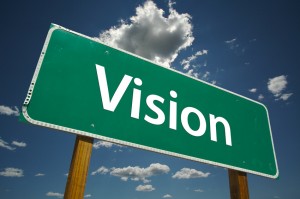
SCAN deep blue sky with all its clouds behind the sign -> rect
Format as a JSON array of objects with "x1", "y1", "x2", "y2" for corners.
[{"x1": 0, "y1": 0, "x2": 300, "y2": 199}]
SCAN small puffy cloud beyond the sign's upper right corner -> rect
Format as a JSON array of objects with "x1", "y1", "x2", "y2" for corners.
[{"x1": 268, "y1": 75, "x2": 293, "y2": 101}]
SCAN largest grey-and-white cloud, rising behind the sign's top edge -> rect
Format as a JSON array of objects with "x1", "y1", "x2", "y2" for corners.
[{"x1": 99, "y1": 0, "x2": 194, "y2": 67}]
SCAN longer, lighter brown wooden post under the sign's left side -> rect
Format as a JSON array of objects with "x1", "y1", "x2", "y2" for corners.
[{"x1": 64, "y1": 135, "x2": 94, "y2": 199}]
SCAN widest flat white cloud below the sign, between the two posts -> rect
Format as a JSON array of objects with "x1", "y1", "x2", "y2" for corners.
[{"x1": 110, "y1": 163, "x2": 170, "y2": 183}]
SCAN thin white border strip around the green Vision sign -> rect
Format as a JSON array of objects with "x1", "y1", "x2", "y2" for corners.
[{"x1": 22, "y1": 23, "x2": 279, "y2": 179}]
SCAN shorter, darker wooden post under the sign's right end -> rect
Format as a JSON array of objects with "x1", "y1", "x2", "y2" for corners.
[{"x1": 228, "y1": 169, "x2": 249, "y2": 199}]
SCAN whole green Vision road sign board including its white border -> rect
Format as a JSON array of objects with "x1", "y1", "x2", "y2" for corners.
[{"x1": 22, "y1": 25, "x2": 278, "y2": 178}]
